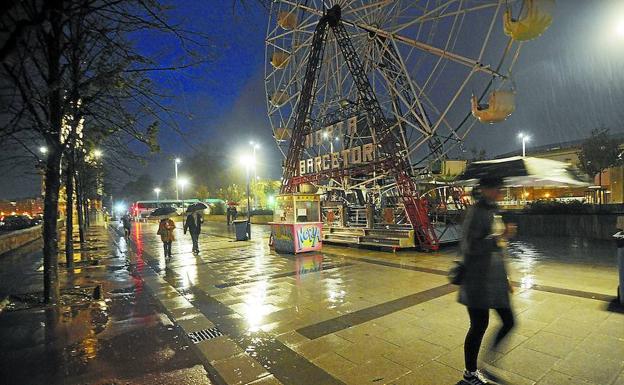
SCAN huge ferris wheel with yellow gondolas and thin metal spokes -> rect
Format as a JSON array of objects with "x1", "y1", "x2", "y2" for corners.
[{"x1": 265, "y1": 0, "x2": 554, "y2": 249}]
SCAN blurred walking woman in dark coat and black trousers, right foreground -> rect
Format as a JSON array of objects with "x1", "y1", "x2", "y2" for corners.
[{"x1": 459, "y1": 178, "x2": 515, "y2": 385}]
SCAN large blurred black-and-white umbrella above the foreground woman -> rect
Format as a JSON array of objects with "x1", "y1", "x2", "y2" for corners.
[{"x1": 457, "y1": 156, "x2": 589, "y2": 187}]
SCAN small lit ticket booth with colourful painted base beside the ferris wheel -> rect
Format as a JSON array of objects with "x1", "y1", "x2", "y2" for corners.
[{"x1": 269, "y1": 193, "x2": 323, "y2": 254}]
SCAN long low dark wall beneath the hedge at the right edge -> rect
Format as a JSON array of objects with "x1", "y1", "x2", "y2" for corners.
[{"x1": 503, "y1": 213, "x2": 618, "y2": 240}]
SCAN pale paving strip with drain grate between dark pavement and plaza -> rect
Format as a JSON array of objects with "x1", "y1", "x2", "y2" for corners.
[{"x1": 108, "y1": 224, "x2": 280, "y2": 385}]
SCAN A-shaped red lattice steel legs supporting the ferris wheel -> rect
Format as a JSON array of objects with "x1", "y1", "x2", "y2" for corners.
[{"x1": 281, "y1": 5, "x2": 439, "y2": 251}]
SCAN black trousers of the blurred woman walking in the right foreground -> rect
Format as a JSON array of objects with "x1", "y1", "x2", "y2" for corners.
[{"x1": 464, "y1": 307, "x2": 514, "y2": 372}]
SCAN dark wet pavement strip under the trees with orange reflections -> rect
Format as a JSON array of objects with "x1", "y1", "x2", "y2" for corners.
[{"x1": 0, "y1": 220, "x2": 212, "y2": 385}]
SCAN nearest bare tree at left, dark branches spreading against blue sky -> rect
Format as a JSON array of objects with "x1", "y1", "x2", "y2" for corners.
[{"x1": 0, "y1": 0, "x2": 212, "y2": 303}]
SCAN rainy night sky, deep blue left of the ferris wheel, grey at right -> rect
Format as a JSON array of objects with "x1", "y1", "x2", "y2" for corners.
[{"x1": 0, "y1": 0, "x2": 624, "y2": 199}]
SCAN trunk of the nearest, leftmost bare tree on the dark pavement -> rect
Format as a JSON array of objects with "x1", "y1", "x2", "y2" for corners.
[{"x1": 43, "y1": 147, "x2": 61, "y2": 303}]
